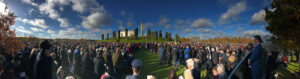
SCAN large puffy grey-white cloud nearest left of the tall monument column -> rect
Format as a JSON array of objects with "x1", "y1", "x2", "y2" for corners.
[{"x1": 81, "y1": 12, "x2": 110, "y2": 30}]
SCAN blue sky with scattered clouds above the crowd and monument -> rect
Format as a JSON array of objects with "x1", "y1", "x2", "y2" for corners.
[{"x1": 1, "y1": 0, "x2": 270, "y2": 39}]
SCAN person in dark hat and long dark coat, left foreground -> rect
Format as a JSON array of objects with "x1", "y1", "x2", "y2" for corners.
[{"x1": 34, "y1": 40, "x2": 52, "y2": 79}]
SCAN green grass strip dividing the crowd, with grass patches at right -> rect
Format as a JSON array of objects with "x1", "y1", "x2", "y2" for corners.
[{"x1": 134, "y1": 49, "x2": 299, "y2": 79}]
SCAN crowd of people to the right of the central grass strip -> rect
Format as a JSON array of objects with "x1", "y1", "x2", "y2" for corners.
[{"x1": 146, "y1": 36, "x2": 299, "y2": 79}]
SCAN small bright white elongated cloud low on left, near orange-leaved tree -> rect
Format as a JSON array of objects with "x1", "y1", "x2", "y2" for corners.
[{"x1": 22, "y1": 19, "x2": 48, "y2": 29}]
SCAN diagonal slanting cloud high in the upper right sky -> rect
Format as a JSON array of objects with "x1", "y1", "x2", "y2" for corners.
[{"x1": 219, "y1": 1, "x2": 246, "y2": 24}]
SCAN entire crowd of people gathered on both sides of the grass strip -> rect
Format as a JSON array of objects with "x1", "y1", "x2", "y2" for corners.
[{"x1": 0, "y1": 36, "x2": 299, "y2": 79}]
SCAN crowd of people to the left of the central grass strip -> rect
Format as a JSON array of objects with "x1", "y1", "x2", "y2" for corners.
[{"x1": 0, "y1": 40, "x2": 141, "y2": 79}]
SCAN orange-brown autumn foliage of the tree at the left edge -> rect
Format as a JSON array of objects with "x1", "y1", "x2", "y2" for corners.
[{"x1": 0, "y1": 4, "x2": 22, "y2": 55}]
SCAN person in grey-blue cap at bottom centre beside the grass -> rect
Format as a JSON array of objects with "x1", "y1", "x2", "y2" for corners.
[{"x1": 126, "y1": 59, "x2": 142, "y2": 79}]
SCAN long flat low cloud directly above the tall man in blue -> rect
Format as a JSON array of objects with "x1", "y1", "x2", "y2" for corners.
[{"x1": 241, "y1": 30, "x2": 270, "y2": 37}]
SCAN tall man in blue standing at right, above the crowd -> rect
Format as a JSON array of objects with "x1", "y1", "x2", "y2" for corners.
[{"x1": 248, "y1": 35, "x2": 265, "y2": 79}]
